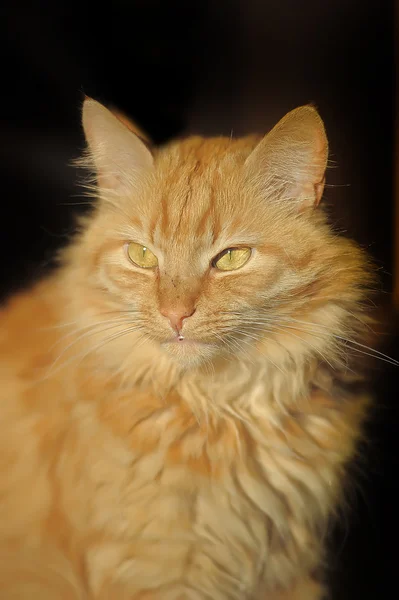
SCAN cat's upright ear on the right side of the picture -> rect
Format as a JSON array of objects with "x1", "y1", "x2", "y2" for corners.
[{"x1": 245, "y1": 106, "x2": 328, "y2": 209}]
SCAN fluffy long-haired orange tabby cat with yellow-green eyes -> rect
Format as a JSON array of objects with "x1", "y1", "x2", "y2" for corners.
[{"x1": 0, "y1": 98, "x2": 374, "y2": 600}]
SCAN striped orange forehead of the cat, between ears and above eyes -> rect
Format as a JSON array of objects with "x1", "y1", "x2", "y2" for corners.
[{"x1": 141, "y1": 137, "x2": 262, "y2": 245}]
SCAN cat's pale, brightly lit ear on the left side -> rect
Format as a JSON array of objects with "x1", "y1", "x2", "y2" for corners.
[{"x1": 82, "y1": 98, "x2": 153, "y2": 193}]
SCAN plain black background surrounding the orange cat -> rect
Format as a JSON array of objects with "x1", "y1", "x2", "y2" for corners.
[{"x1": 0, "y1": 0, "x2": 399, "y2": 600}]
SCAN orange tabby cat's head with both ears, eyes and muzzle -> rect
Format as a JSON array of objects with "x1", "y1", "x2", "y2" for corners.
[{"x1": 71, "y1": 99, "x2": 367, "y2": 367}]
